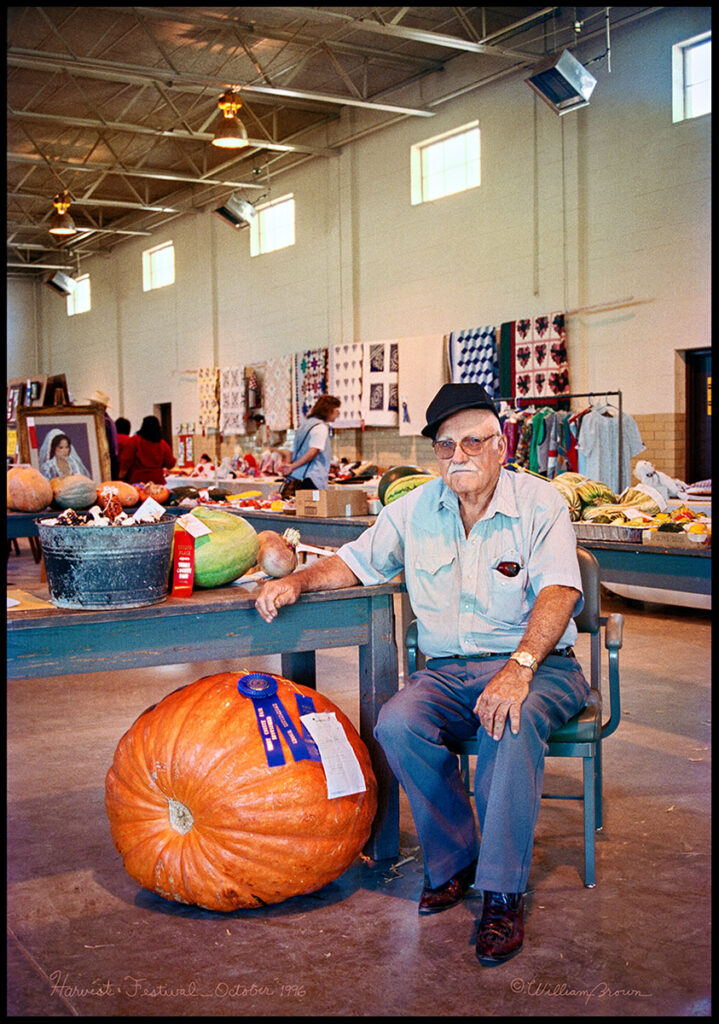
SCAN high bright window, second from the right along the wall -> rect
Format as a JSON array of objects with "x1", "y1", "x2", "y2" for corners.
[{"x1": 411, "y1": 121, "x2": 479, "y2": 206}]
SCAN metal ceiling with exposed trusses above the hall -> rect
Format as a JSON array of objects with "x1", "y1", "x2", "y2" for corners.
[{"x1": 7, "y1": 6, "x2": 657, "y2": 278}]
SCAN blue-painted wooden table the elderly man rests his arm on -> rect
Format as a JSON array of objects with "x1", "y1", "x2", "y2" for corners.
[{"x1": 7, "y1": 573, "x2": 404, "y2": 859}]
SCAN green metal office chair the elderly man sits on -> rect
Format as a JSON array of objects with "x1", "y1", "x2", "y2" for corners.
[{"x1": 405, "y1": 547, "x2": 624, "y2": 889}]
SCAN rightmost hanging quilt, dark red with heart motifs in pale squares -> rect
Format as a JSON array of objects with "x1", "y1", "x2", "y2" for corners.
[{"x1": 500, "y1": 312, "x2": 569, "y2": 404}]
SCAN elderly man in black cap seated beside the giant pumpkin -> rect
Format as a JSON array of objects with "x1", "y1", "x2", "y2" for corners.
[{"x1": 255, "y1": 384, "x2": 589, "y2": 967}]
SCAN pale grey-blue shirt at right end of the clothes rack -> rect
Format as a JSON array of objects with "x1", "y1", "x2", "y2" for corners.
[{"x1": 577, "y1": 406, "x2": 646, "y2": 495}]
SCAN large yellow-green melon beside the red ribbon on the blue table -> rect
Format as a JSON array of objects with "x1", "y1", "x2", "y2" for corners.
[{"x1": 192, "y1": 507, "x2": 259, "y2": 589}]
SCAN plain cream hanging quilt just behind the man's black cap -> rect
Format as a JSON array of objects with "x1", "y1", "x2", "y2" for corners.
[{"x1": 397, "y1": 334, "x2": 449, "y2": 437}]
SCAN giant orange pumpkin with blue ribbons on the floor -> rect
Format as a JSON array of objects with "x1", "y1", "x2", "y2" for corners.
[{"x1": 105, "y1": 672, "x2": 377, "y2": 910}]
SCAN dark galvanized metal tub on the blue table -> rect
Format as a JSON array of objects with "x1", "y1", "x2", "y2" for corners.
[{"x1": 36, "y1": 515, "x2": 175, "y2": 610}]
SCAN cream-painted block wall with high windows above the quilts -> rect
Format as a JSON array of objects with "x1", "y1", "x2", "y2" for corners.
[{"x1": 8, "y1": 7, "x2": 711, "y2": 429}]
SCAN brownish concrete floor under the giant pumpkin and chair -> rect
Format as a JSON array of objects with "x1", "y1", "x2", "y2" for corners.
[{"x1": 7, "y1": 546, "x2": 711, "y2": 1017}]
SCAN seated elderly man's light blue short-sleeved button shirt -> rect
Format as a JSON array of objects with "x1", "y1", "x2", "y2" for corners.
[{"x1": 337, "y1": 469, "x2": 584, "y2": 657}]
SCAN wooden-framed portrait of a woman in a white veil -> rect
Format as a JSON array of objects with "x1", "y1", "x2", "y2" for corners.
[{"x1": 16, "y1": 404, "x2": 111, "y2": 483}]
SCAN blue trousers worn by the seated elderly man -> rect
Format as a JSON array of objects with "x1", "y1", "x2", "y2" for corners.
[{"x1": 375, "y1": 654, "x2": 589, "y2": 892}]
